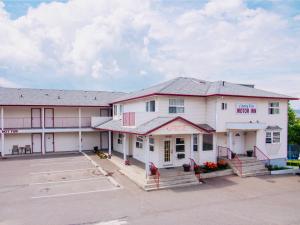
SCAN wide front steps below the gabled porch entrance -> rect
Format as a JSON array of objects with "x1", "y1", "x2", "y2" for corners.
[{"x1": 144, "y1": 168, "x2": 199, "y2": 191}]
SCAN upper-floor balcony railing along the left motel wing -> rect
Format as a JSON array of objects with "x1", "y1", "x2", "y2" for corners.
[{"x1": 4, "y1": 117, "x2": 91, "y2": 129}]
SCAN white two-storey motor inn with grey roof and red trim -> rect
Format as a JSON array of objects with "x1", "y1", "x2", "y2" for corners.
[{"x1": 0, "y1": 77, "x2": 297, "y2": 179}]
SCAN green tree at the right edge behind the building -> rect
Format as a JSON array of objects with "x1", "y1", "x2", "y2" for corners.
[{"x1": 288, "y1": 105, "x2": 300, "y2": 145}]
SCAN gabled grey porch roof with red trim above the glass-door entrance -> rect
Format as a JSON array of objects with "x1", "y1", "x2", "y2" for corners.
[{"x1": 94, "y1": 117, "x2": 215, "y2": 135}]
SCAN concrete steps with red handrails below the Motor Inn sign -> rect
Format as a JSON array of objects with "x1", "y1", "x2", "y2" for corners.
[{"x1": 228, "y1": 155, "x2": 270, "y2": 177}]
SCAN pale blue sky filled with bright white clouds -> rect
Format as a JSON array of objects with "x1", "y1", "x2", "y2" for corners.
[{"x1": 0, "y1": 0, "x2": 300, "y2": 109}]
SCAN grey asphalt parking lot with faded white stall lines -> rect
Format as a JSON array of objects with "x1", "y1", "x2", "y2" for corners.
[{"x1": 0, "y1": 154, "x2": 300, "y2": 225}]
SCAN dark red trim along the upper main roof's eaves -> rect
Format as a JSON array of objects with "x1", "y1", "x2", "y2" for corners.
[{"x1": 110, "y1": 93, "x2": 299, "y2": 104}]
